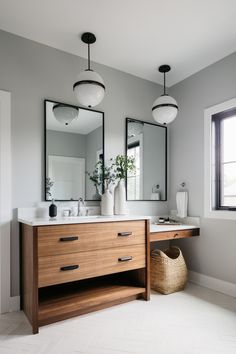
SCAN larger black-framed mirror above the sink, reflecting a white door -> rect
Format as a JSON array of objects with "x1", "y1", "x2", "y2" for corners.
[{"x1": 45, "y1": 100, "x2": 104, "y2": 200}]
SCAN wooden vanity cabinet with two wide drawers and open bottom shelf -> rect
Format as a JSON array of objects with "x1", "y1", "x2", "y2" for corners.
[{"x1": 21, "y1": 220, "x2": 150, "y2": 333}]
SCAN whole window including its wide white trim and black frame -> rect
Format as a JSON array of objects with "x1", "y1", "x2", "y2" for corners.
[{"x1": 204, "y1": 98, "x2": 236, "y2": 220}]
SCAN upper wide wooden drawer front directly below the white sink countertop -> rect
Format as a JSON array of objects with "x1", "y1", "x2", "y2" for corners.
[{"x1": 38, "y1": 220, "x2": 145, "y2": 257}]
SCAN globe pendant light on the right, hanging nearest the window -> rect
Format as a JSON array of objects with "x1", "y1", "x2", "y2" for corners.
[{"x1": 152, "y1": 65, "x2": 178, "y2": 124}]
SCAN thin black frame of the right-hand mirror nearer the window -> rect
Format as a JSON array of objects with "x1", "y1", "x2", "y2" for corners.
[{"x1": 125, "y1": 117, "x2": 167, "y2": 202}]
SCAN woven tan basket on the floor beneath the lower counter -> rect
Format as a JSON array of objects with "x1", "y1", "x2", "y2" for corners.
[{"x1": 151, "y1": 246, "x2": 188, "y2": 294}]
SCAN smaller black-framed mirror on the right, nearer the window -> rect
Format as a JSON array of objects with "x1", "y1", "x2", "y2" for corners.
[{"x1": 126, "y1": 118, "x2": 167, "y2": 201}]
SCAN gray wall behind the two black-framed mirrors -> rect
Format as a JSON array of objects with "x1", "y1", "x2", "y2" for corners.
[{"x1": 0, "y1": 31, "x2": 168, "y2": 295}]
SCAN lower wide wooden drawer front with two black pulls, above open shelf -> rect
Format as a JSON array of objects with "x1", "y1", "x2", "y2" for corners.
[{"x1": 38, "y1": 245, "x2": 146, "y2": 287}]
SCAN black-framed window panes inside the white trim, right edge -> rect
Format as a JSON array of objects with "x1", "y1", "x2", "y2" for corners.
[{"x1": 212, "y1": 108, "x2": 236, "y2": 210}]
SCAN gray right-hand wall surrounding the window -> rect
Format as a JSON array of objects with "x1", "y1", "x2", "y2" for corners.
[{"x1": 170, "y1": 53, "x2": 236, "y2": 283}]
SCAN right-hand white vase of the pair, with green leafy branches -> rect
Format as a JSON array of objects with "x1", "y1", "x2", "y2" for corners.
[{"x1": 114, "y1": 155, "x2": 135, "y2": 215}]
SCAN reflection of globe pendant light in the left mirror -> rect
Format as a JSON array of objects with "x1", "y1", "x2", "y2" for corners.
[{"x1": 52, "y1": 103, "x2": 79, "y2": 125}]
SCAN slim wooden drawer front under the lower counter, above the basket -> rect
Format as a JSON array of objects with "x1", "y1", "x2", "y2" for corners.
[{"x1": 150, "y1": 228, "x2": 200, "y2": 242}]
